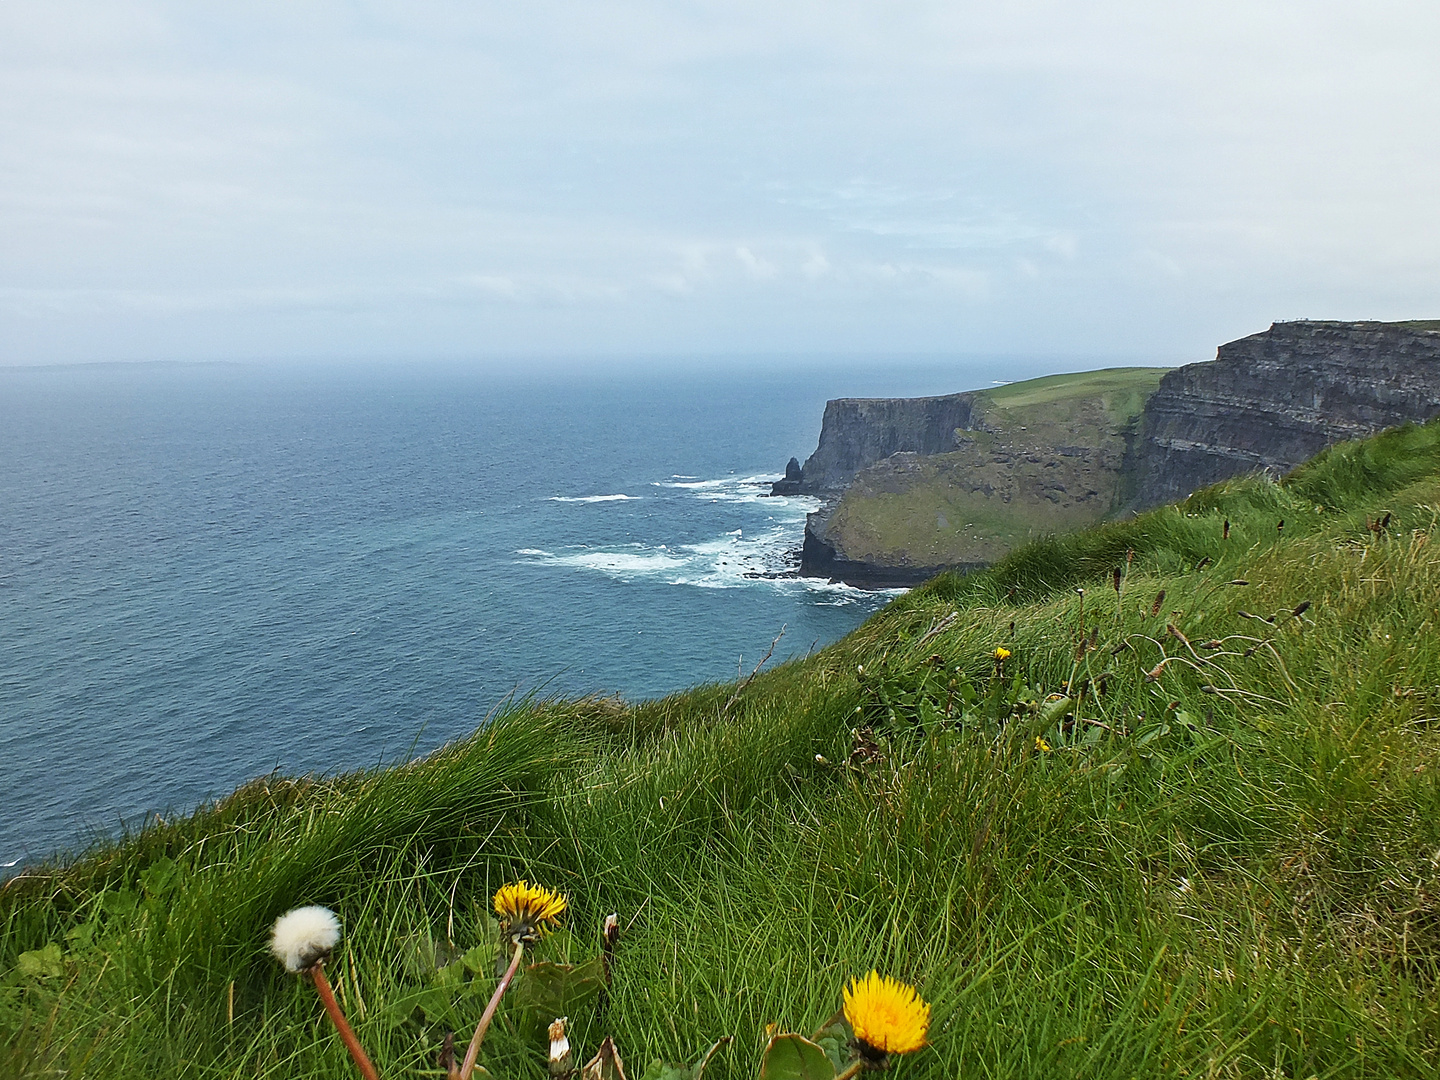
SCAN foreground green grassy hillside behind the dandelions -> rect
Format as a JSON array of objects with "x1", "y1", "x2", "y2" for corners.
[{"x1": 0, "y1": 425, "x2": 1440, "y2": 1080}]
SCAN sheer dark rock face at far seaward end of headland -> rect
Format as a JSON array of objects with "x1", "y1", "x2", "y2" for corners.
[{"x1": 773, "y1": 393, "x2": 975, "y2": 495}]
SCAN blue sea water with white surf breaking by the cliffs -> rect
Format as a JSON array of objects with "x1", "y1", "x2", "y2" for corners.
[{"x1": 0, "y1": 364, "x2": 1036, "y2": 864}]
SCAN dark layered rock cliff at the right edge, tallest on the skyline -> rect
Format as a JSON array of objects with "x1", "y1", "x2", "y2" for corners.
[{"x1": 1128, "y1": 321, "x2": 1440, "y2": 510}]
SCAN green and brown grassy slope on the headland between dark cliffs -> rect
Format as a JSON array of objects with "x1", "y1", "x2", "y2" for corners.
[{"x1": 827, "y1": 367, "x2": 1168, "y2": 566}]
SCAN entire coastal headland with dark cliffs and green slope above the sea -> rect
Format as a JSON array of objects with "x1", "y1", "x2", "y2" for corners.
[{"x1": 775, "y1": 321, "x2": 1440, "y2": 585}]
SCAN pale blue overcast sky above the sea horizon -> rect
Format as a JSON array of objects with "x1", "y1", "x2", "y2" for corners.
[{"x1": 0, "y1": 0, "x2": 1440, "y2": 366}]
